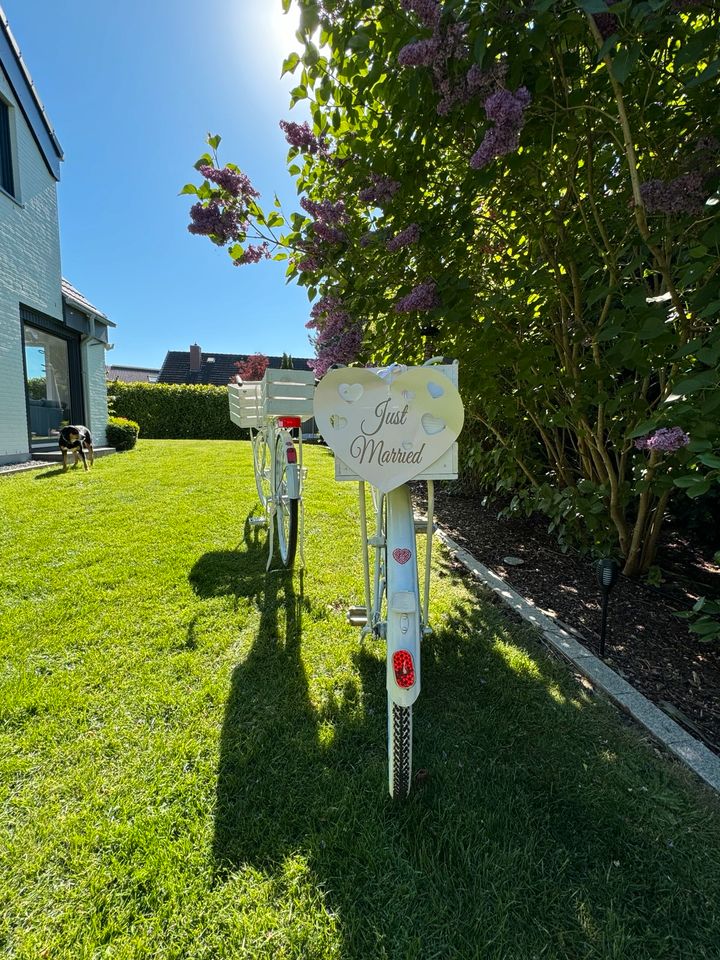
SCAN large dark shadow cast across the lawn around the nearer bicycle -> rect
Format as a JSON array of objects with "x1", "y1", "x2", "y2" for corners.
[{"x1": 200, "y1": 536, "x2": 720, "y2": 960}]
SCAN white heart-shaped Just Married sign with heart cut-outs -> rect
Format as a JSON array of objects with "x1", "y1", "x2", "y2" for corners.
[{"x1": 314, "y1": 367, "x2": 464, "y2": 493}]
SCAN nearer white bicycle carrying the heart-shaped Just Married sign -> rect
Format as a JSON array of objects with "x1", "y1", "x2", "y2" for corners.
[{"x1": 315, "y1": 358, "x2": 462, "y2": 799}]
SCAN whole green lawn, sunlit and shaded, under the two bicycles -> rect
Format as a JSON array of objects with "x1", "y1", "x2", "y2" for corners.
[{"x1": 0, "y1": 441, "x2": 720, "y2": 960}]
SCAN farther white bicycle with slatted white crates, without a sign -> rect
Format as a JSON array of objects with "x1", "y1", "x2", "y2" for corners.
[{"x1": 228, "y1": 370, "x2": 315, "y2": 569}]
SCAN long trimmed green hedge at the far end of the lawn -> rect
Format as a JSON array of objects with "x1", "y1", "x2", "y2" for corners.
[{"x1": 108, "y1": 380, "x2": 247, "y2": 440}]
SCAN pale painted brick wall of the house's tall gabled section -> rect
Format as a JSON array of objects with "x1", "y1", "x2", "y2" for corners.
[{"x1": 0, "y1": 70, "x2": 63, "y2": 463}]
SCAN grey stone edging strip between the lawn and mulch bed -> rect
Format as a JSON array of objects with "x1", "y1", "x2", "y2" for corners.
[{"x1": 435, "y1": 527, "x2": 720, "y2": 792}]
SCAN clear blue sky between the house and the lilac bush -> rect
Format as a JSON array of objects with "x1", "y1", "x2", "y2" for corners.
[{"x1": 0, "y1": 0, "x2": 312, "y2": 367}]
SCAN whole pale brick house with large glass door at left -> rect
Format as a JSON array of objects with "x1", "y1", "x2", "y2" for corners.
[{"x1": 0, "y1": 7, "x2": 114, "y2": 464}]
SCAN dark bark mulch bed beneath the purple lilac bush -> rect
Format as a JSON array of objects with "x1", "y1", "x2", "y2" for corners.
[{"x1": 415, "y1": 488, "x2": 720, "y2": 754}]
